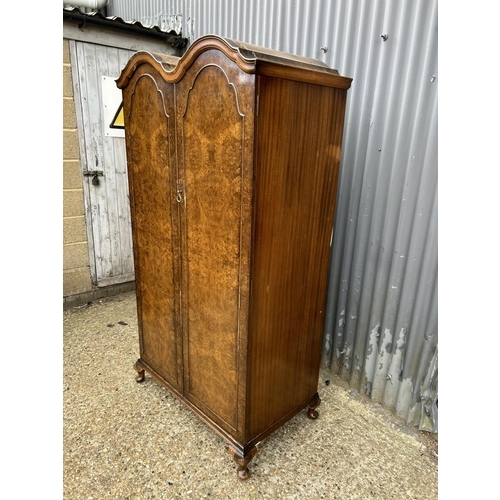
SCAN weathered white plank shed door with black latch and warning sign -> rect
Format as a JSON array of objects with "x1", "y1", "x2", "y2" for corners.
[{"x1": 70, "y1": 40, "x2": 134, "y2": 286}]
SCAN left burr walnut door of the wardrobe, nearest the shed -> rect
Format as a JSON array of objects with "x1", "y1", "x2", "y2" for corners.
[{"x1": 123, "y1": 64, "x2": 183, "y2": 392}]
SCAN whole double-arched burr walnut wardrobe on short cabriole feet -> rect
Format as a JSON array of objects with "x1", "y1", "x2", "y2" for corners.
[{"x1": 117, "y1": 36, "x2": 351, "y2": 479}]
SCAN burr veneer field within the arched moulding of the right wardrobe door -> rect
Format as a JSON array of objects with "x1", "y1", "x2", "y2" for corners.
[{"x1": 182, "y1": 61, "x2": 244, "y2": 429}]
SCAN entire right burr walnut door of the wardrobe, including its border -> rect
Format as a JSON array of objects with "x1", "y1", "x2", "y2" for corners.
[{"x1": 176, "y1": 51, "x2": 253, "y2": 434}]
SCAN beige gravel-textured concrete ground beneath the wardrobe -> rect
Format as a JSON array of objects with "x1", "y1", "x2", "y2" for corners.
[{"x1": 64, "y1": 292, "x2": 438, "y2": 500}]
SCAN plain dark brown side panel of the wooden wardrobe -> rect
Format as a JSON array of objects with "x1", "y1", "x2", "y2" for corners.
[{"x1": 247, "y1": 76, "x2": 346, "y2": 440}]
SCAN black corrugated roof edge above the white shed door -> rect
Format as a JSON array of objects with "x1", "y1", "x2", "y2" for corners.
[{"x1": 63, "y1": 7, "x2": 188, "y2": 49}]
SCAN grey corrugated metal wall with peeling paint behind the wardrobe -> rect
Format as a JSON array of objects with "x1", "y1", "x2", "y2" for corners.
[{"x1": 108, "y1": 0, "x2": 438, "y2": 432}]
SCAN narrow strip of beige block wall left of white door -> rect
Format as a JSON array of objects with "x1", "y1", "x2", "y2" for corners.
[{"x1": 63, "y1": 40, "x2": 92, "y2": 297}]
